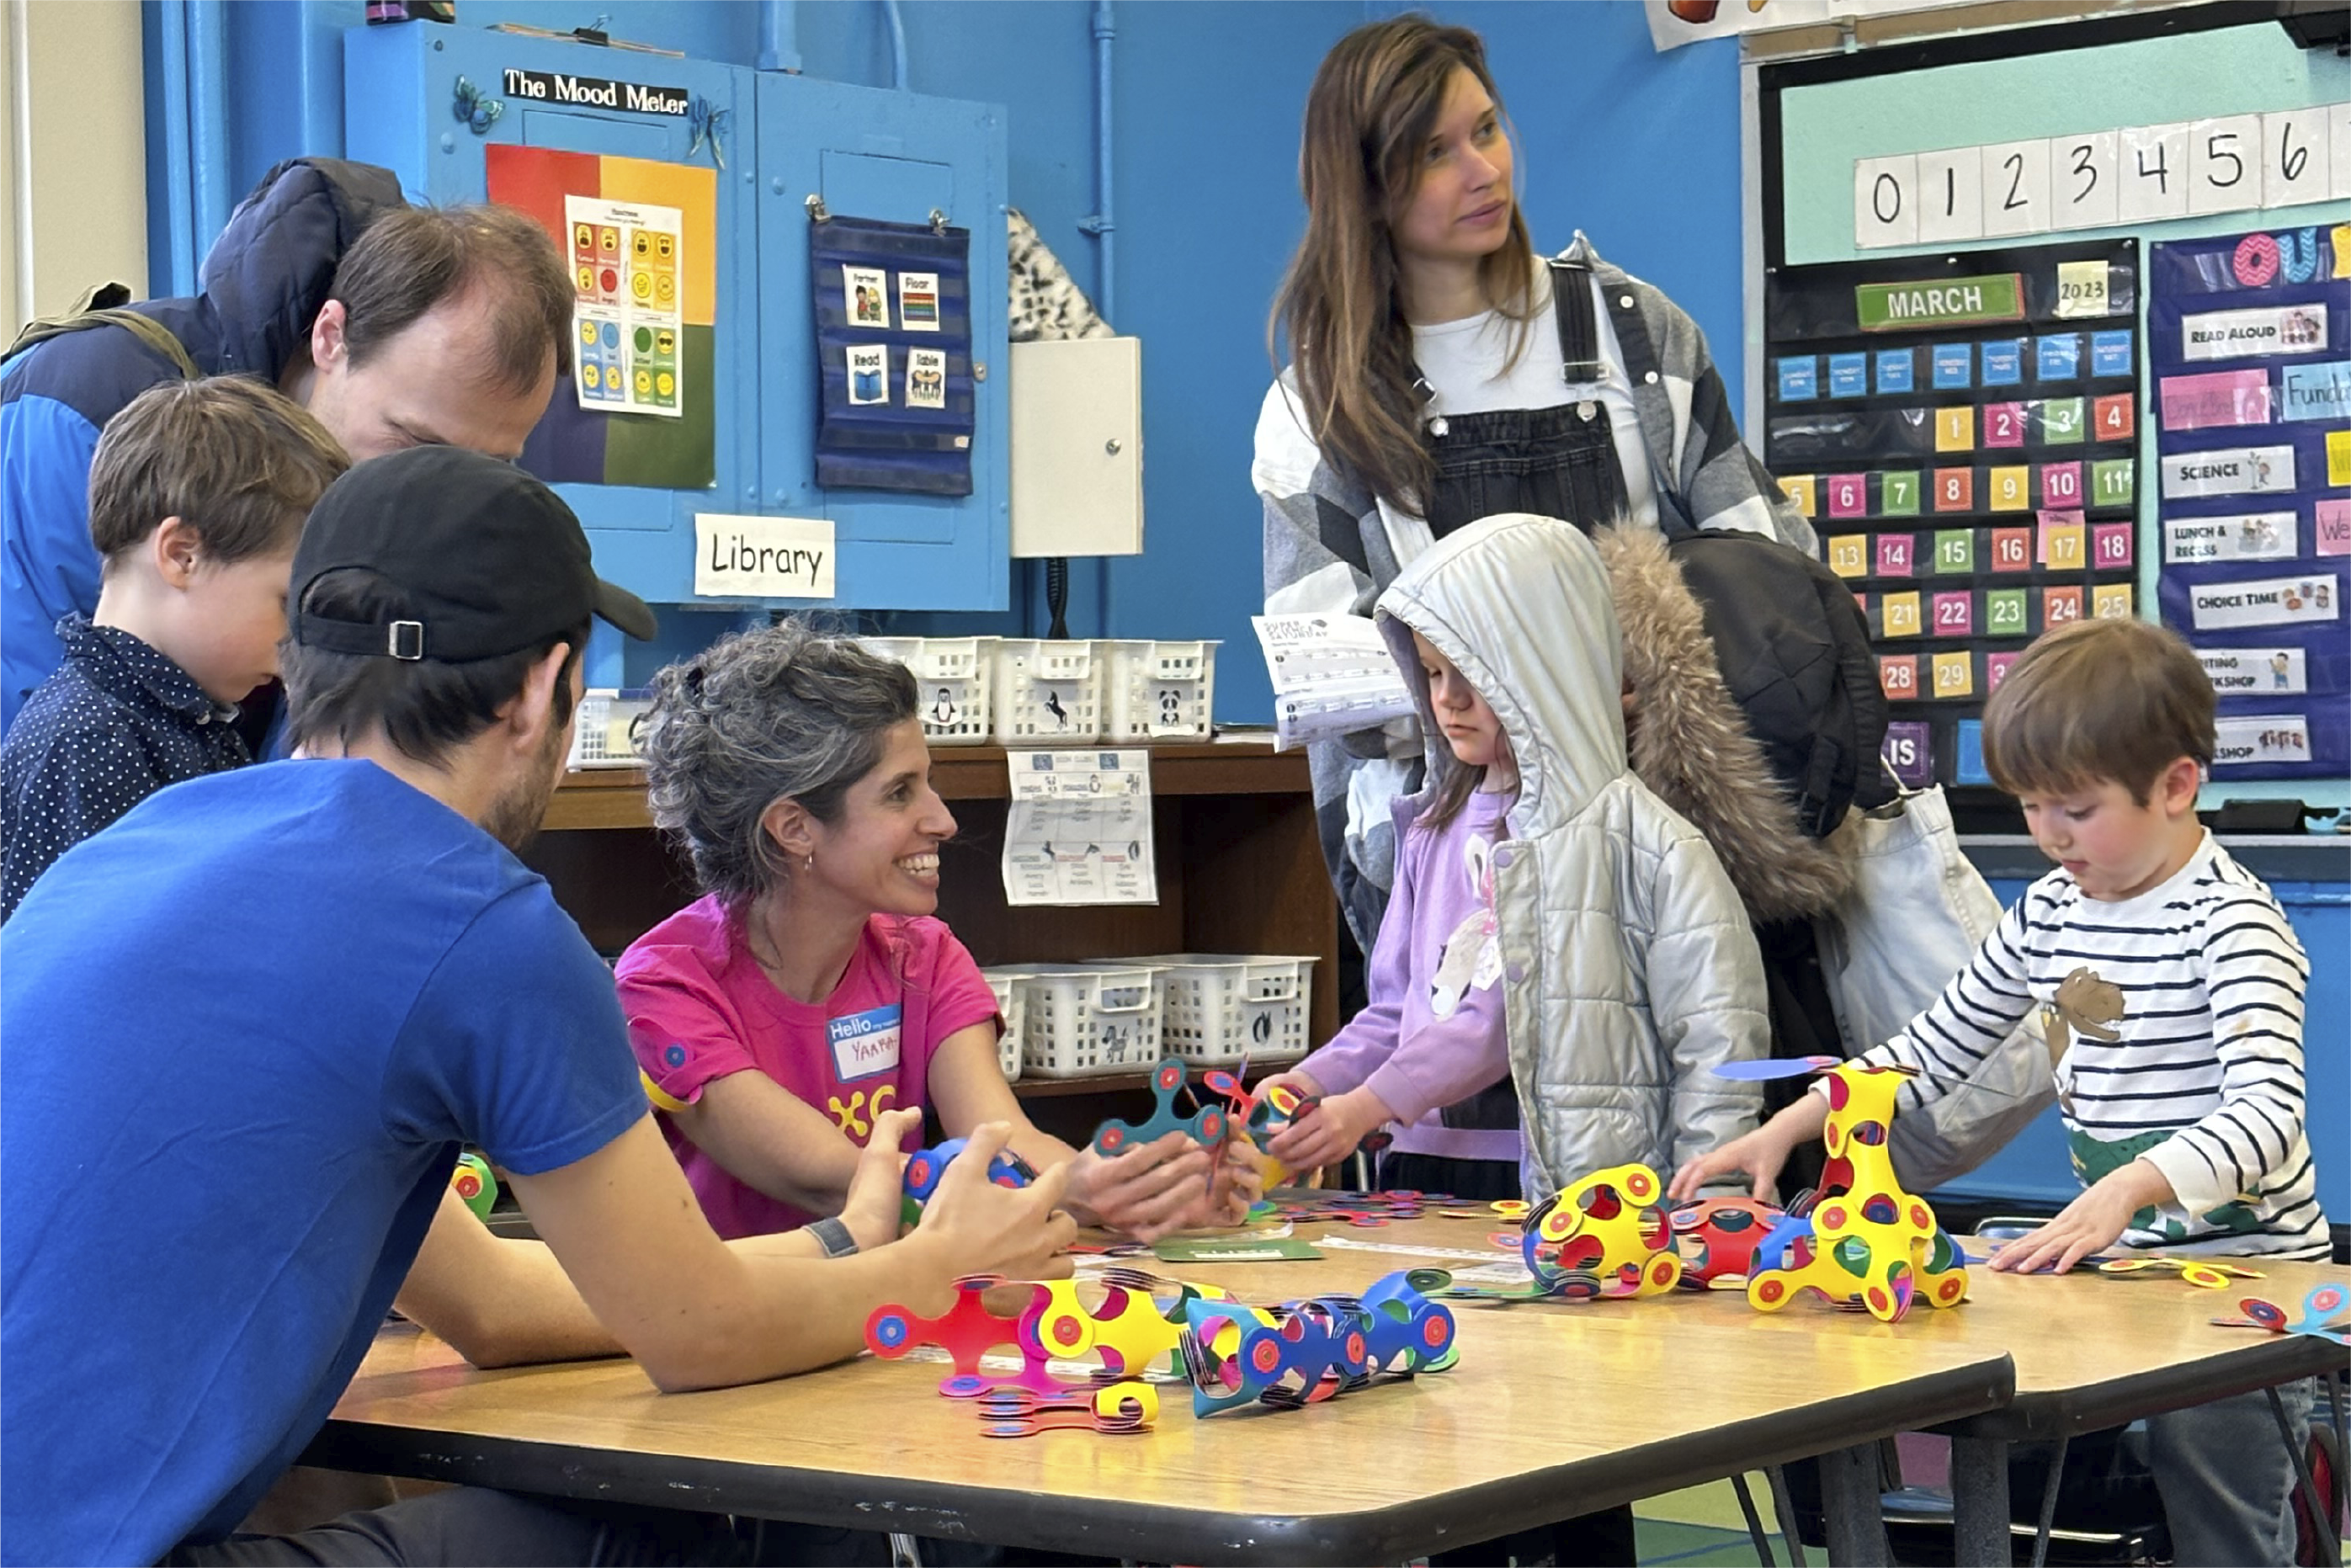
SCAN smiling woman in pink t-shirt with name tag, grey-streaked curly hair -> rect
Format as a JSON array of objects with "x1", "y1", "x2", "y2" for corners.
[{"x1": 619, "y1": 623, "x2": 1234, "y2": 1236}]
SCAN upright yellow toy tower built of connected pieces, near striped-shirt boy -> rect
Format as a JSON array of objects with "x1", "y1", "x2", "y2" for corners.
[{"x1": 1747, "y1": 1062, "x2": 1968, "y2": 1324}]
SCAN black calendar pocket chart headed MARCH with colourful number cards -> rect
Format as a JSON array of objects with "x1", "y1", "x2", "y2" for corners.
[{"x1": 1763, "y1": 240, "x2": 2144, "y2": 788}]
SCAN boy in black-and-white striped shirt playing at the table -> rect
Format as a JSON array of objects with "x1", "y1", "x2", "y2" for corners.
[{"x1": 1674, "y1": 620, "x2": 2330, "y2": 1568}]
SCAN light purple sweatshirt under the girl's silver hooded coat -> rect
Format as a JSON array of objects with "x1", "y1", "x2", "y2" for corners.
[{"x1": 1298, "y1": 792, "x2": 1519, "y2": 1164}]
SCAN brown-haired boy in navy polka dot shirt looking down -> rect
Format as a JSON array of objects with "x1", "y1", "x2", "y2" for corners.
[{"x1": 0, "y1": 376, "x2": 348, "y2": 922}]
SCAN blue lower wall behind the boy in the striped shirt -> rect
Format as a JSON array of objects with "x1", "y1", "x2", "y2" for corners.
[{"x1": 1947, "y1": 881, "x2": 2351, "y2": 1225}]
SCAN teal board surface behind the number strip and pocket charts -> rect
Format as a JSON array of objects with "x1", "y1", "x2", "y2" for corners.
[{"x1": 1747, "y1": 3, "x2": 2351, "y2": 809}]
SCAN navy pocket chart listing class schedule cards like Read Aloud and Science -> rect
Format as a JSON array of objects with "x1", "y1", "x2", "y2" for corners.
[{"x1": 2146, "y1": 226, "x2": 2351, "y2": 779}]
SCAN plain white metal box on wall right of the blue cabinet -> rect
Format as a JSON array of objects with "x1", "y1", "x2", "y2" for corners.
[{"x1": 1011, "y1": 338, "x2": 1142, "y2": 557}]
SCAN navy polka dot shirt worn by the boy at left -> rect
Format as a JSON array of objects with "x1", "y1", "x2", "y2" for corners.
[{"x1": 0, "y1": 616, "x2": 254, "y2": 922}]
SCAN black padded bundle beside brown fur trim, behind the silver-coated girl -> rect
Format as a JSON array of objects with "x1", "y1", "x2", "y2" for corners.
[{"x1": 1667, "y1": 529, "x2": 1895, "y2": 839}]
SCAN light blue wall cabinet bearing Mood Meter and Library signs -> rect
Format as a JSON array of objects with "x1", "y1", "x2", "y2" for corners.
[{"x1": 343, "y1": 24, "x2": 1011, "y2": 609}]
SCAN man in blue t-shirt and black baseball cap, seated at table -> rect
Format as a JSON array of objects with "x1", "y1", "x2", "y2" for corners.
[{"x1": 0, "y1": 447, "x2": 1072, "y2": 1568}]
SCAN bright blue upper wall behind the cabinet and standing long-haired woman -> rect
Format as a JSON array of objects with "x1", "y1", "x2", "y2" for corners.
[{"x1": 165, "y1": 0, "x2": 1742, "y2": 724}]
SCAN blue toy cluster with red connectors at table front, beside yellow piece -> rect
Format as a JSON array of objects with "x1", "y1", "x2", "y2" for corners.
[{"x1": 1183, "y1": 1269, "x2": 1455, "y2": 1415}]
